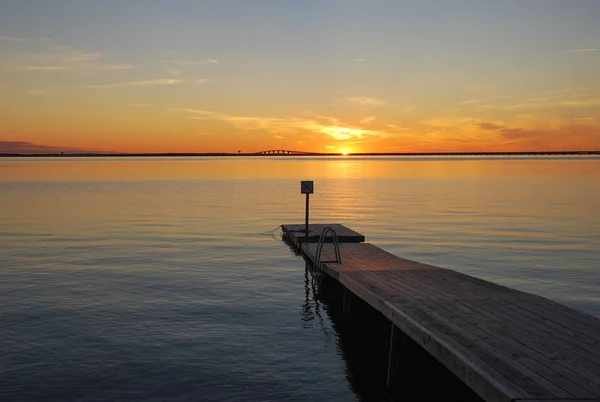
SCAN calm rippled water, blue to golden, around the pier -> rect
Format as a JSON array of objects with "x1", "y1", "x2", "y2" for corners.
[{"x1": 0, "y1": 157, "x2": 600, "y2": 401}]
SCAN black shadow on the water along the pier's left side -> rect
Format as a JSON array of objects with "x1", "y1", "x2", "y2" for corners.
[{"x1": 302, "y1": 261, "x2": 482, "y2": 402}]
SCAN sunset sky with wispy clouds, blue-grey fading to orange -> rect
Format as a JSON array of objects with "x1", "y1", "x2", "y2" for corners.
[{"x1": 0, "y1": 0, "x2": 600, "y2": 152}]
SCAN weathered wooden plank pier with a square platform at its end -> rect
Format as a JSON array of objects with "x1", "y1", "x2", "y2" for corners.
[{"x1": 282, "y1": 225, "x2": 600, "y2": 402}]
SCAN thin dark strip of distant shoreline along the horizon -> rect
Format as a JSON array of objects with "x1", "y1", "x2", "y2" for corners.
[{"x1": 0, "y1": 151, "x2": 600, "y2": 158}]
